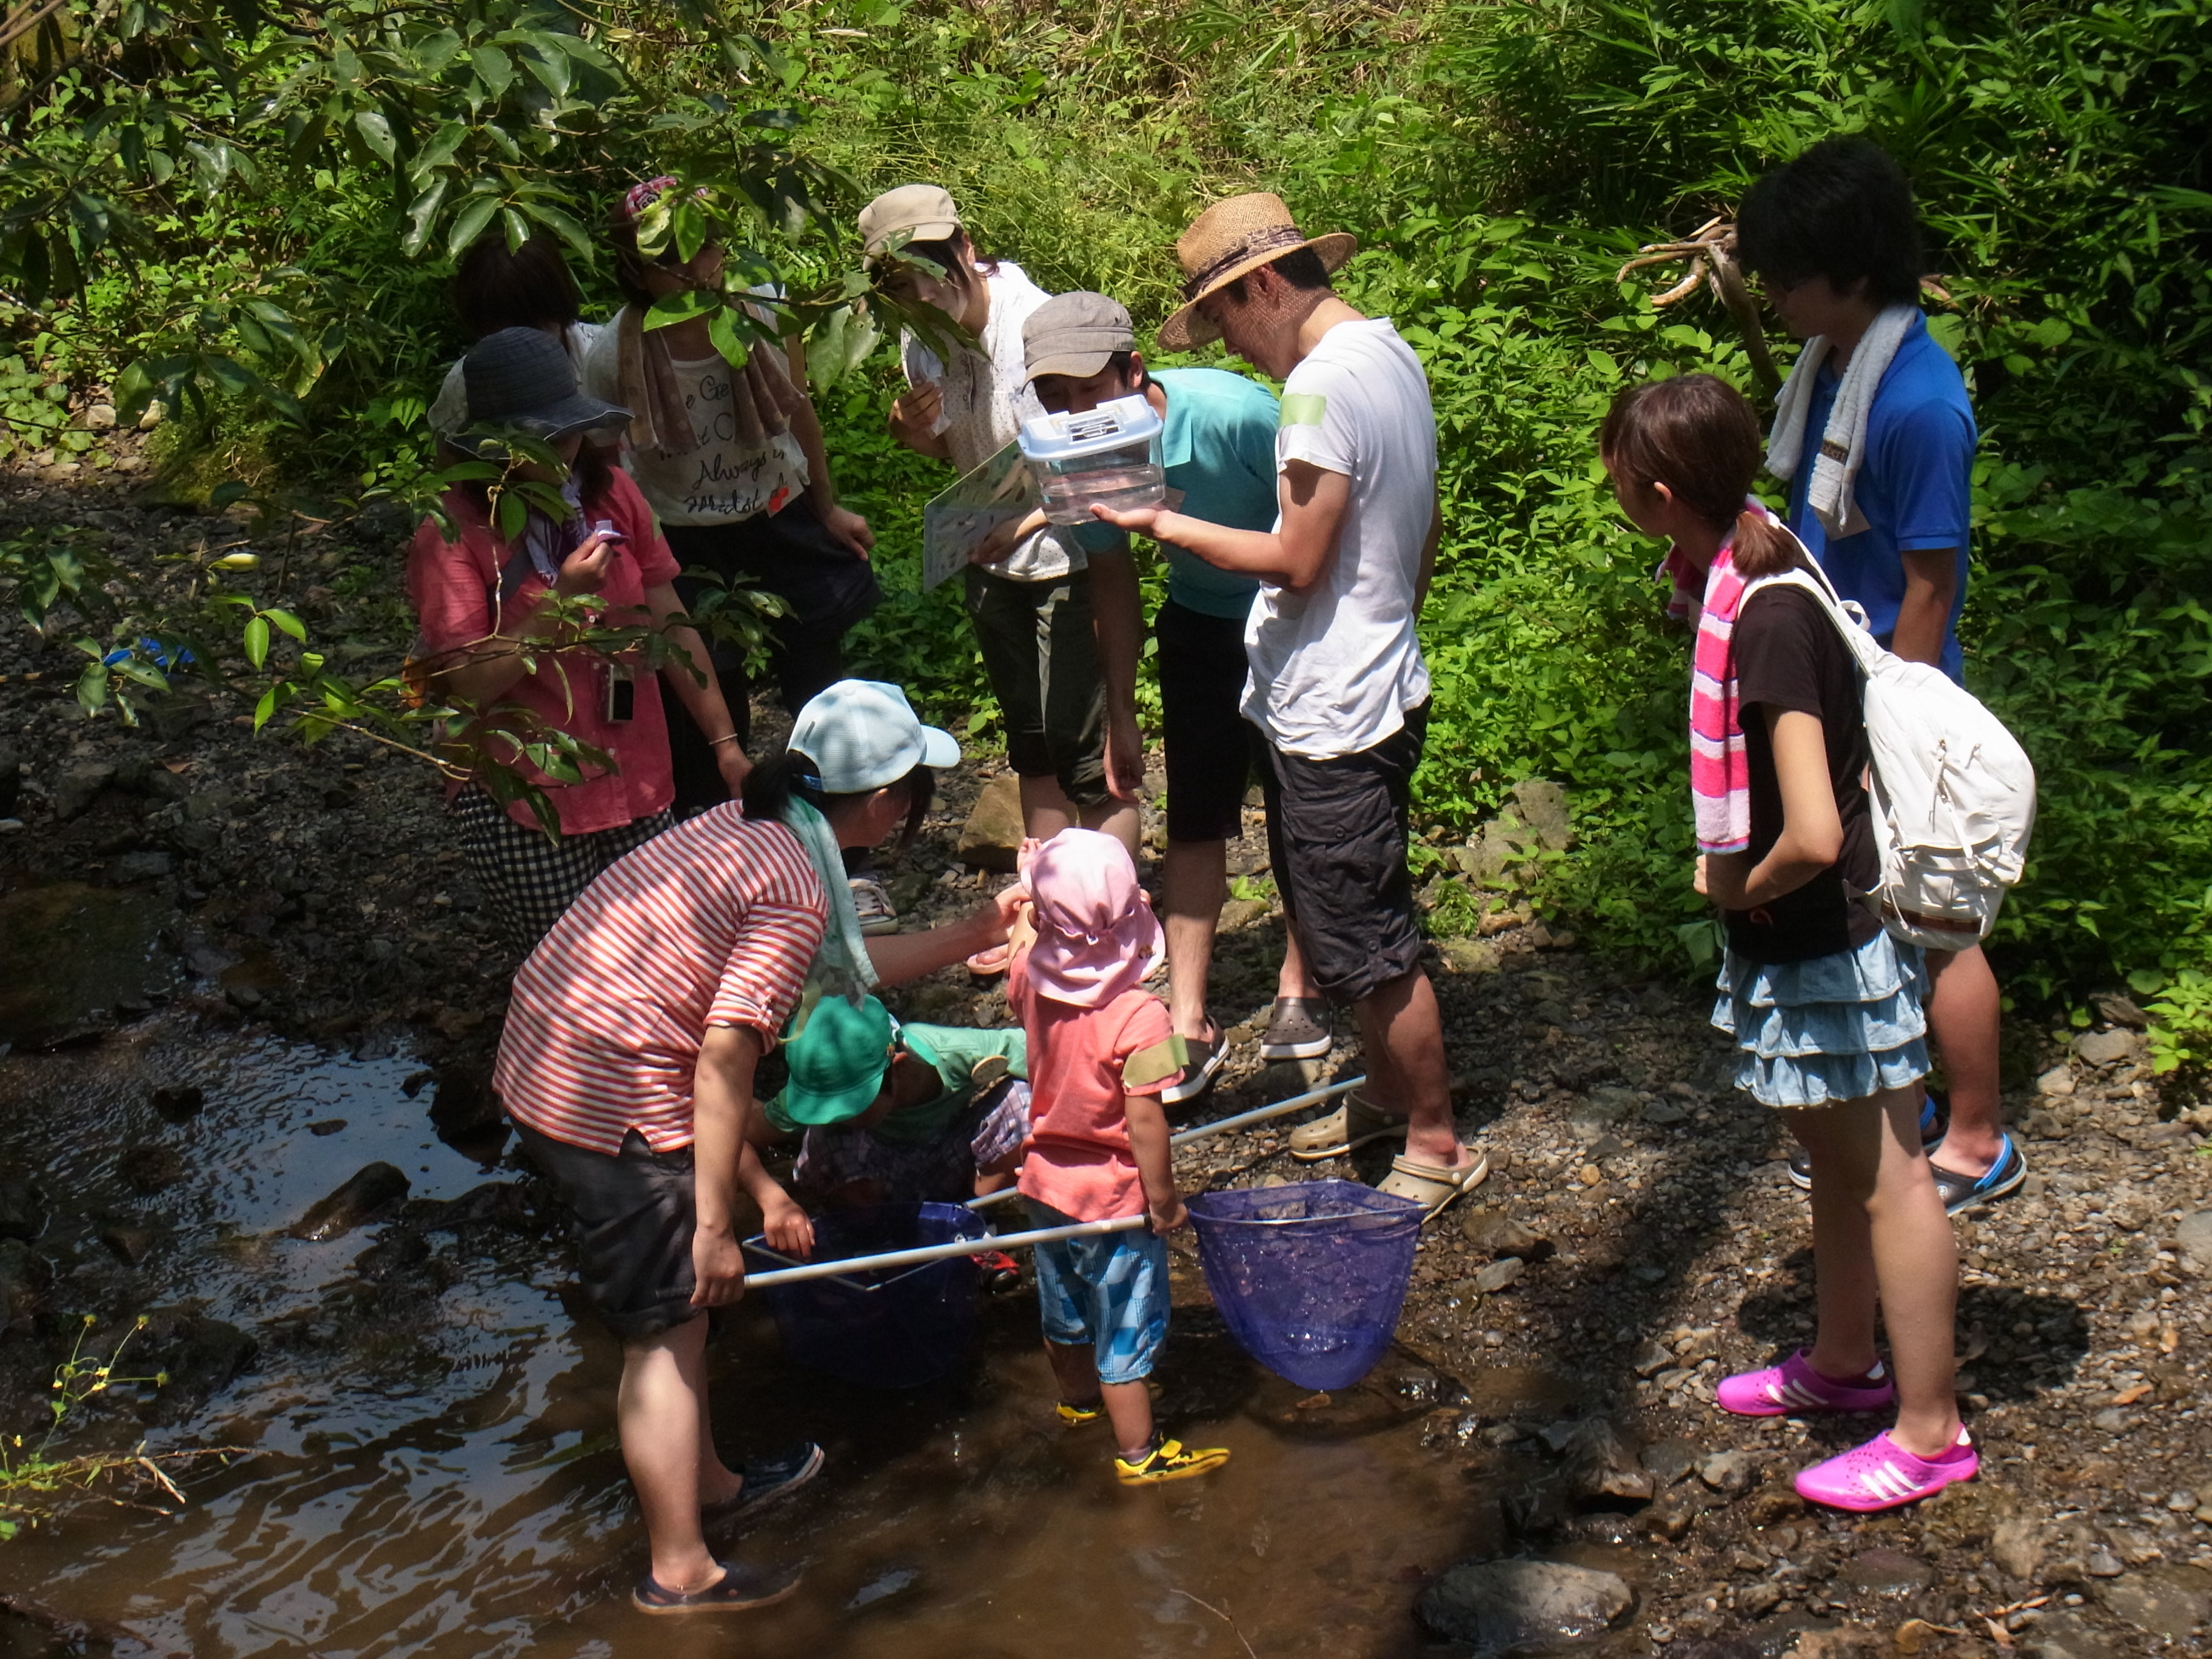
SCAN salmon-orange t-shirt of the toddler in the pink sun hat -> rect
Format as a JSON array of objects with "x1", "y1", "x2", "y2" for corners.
[{"x1": 1007, "y1": 949, "x2": 1179, "y2": 1221}]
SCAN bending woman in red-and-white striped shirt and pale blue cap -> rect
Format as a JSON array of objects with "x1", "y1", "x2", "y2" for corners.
[{"x1": 494, "y1": 679, "x2": 1020, "y2": 1612}]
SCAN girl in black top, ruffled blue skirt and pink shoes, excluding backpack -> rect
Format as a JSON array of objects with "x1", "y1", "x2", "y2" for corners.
[{"x1": 1600, "y1": 374, "x2": 1980, "y2": 1511}]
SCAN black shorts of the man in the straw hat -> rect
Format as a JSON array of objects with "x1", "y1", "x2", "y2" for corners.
[{"x1": 1261, "y1": 703, "x2": 1429, "y2": 1007}]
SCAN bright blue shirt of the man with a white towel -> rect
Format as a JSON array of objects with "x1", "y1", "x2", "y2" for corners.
[{"x1": 1789, "y1": 317, "x2": 1976, "y2": 679}]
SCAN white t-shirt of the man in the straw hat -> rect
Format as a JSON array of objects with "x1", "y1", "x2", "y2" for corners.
[{"x1": 1243, "y1": 318, "x2": 1436, "y2": 761}]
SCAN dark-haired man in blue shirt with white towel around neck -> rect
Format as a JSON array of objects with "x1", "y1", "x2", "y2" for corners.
[{"x1": 1737, "y1": 137, "x2": 2026, "y2": 1210}]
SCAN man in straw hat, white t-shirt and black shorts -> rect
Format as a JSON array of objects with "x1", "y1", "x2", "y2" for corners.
[{"x1": 1093, "y1": 195, "x2": 1489, "y2": 1212}]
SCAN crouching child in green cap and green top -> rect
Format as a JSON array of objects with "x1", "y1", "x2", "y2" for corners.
[{"x1": 752, "y1": 996, "x2": 1028, "y2": 1208}]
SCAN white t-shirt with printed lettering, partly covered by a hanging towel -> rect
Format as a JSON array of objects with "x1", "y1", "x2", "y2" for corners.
[{"x1": 584, "y1": 307, "x2": 808, "y2": 525}]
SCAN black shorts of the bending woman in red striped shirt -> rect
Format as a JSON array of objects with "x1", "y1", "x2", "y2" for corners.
[{"x1": 515, "y1": 1122, "x2": 708, "y2": 1342}]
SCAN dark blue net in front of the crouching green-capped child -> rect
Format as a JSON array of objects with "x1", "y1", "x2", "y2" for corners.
[{"x1": 757, "y1": 1204, "x2": 989, "y2": 1389}]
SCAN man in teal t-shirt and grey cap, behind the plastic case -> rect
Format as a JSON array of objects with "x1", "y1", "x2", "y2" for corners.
[{"x1": 1022, "y1": 294, "x2": 1332, "y2": 1104}]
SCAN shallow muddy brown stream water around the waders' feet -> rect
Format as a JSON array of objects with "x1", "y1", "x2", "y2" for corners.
[{"x1": 0, "y1": 1027, "x2": 1530, "y2": 1659}]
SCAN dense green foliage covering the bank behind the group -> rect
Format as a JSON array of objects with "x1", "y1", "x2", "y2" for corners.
[{"x1": 13, "y1": 0, "x2": 2212, "y2": 1064}]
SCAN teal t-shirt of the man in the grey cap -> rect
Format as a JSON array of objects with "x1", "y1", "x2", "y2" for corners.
[{"x1": 1079, "y1": 369, "x2": 1281, "y2": 622}]
